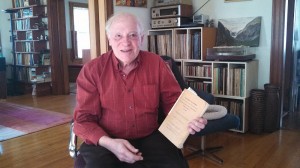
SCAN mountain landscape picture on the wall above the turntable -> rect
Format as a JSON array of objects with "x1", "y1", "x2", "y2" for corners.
[{"x1": 217, "y1": 16, "x2": 261, "y2": 47}]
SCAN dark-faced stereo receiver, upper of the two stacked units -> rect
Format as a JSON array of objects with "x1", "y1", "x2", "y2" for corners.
[{"x1": 151, "y1": 4, "x2": 193, "y2": 19}]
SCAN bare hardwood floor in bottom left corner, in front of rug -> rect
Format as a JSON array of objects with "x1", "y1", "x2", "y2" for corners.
[{"x1": 0, "y1": 124, "x2": 73, "y2": 168}]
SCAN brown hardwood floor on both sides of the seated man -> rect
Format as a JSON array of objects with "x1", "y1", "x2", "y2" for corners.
[{"x1": 0, "y1": 94, "x2": 300, "y2": 168}]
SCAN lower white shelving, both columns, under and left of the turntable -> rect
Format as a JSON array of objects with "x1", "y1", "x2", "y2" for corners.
[{"x1": 183, "y1": 60, "x2": 258, "y2": 133}]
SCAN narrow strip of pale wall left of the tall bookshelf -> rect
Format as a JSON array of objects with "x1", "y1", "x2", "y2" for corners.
[{"x1": 0, "y1": 0, "x2": 12, "y2": 64}]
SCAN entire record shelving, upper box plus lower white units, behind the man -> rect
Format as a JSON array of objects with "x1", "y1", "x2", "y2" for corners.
[{"x1": 148, "y1": 27, "x2": 258, "y2": 133}]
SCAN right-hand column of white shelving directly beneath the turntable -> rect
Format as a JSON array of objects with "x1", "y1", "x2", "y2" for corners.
[{"x1": 212, "y1": 60, "x2": 258, "y2": 133}]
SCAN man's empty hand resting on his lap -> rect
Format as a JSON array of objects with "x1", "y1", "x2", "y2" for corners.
[{"x1": 99, "y1": 136, "x2": 143, "y2": 163}]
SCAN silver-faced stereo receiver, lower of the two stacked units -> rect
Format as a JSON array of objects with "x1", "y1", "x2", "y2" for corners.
[{"x1": 151, "y1": 17, "x2": 191, "y2": 29}]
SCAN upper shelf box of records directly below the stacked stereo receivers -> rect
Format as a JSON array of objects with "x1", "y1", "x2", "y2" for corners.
[{"x1": 148, "y1": 27, "x2": 217, "y2": 72}]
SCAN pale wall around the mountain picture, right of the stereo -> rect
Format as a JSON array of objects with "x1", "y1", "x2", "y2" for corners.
[{"x1": 193, "y1": 0, "x2": 272, "y2": 89}]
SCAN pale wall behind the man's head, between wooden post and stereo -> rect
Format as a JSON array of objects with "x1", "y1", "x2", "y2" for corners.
[{"x1": 114, "y1": 0, "x2": 153, "y2": 50}]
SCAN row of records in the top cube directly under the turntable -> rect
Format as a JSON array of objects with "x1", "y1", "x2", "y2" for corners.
[{"x1": 213, "y1": 67, "x2": 245, "y2": 97}]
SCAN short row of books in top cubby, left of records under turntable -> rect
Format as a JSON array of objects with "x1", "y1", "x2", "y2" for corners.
[{"x1": 185, "y1": 65, "x2": 211, "y2": 77}]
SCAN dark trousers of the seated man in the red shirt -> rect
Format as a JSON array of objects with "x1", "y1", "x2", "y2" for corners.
[{"x1": 80, "y1": 131, "x2": 188, "y2": 168}]
